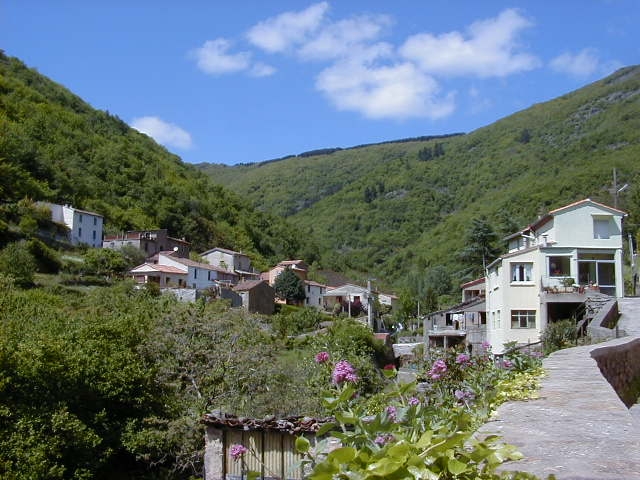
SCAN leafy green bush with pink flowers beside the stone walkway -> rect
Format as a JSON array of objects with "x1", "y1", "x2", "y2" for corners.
[{"x1": 296, "y1": 352, "x2": 535, "y2": 480}]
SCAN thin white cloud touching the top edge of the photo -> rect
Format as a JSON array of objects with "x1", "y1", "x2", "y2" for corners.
[{"x1": 247, "y1": 2, "x2": 329, "y2": 53}]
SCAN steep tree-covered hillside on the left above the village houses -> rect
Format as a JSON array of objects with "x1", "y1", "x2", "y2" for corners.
[{"x1": 0, "y1": 52, "x2": 310, "y2": 265}]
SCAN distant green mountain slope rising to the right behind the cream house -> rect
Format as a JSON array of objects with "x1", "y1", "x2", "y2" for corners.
[{"x1": 200, "y1": 67, "x2": 640, "y2": 283}]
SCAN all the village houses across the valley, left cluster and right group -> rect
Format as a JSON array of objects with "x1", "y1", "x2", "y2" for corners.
[{"x1": 40, "y1": 195, "x2": 632, "y2": 354}]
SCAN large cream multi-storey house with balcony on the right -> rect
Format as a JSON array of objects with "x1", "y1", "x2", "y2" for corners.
[{"x1": 485, "y1": 199, "x2": 626, "y2": 353}]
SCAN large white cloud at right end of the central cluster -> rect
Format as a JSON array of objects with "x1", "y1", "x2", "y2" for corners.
[{"x1": 400, "y1": 9, "x2": 540, "y2": 77}]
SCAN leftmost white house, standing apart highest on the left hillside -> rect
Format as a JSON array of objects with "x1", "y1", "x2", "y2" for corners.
[{"x1": 42, "y1": 202, "x2": 104, "y2": 248}]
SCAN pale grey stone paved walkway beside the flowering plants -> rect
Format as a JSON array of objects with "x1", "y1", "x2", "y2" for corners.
[{"x1": 480, "y1": 298, "x2": 640, "y2": 480}]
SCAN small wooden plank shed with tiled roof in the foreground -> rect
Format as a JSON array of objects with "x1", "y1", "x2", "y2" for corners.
[{"x1": 202, "y1": 411, "x2": 333, "y2": 480}]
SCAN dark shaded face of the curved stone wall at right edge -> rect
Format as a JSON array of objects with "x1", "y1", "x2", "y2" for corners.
[{"x1": 591, "y1": 338, "x2": 640, "y2": 408}]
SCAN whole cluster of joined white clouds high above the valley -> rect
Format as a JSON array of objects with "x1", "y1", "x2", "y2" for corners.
[{"x1": 197, "y1": 1, "x2": 541, "y2": 119}]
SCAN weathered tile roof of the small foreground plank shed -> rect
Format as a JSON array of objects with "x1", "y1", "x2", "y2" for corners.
[{"x1": 202, "y1": 412, "x2": 335, "y2": 435}]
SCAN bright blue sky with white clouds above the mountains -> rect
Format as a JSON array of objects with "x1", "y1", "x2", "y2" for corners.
[{"x1": 0, "y1": 0, "x2": 640, "y2": 164}]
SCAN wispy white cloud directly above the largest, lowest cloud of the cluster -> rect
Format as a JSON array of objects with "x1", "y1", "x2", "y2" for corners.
[{"x1": 298, "y1": 15, "x2": 392, "y2": 60}]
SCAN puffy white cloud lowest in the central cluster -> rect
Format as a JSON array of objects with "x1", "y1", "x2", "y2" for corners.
[{"x1": 316, "y1": 61, "x2": 454, "y2": 119}]
